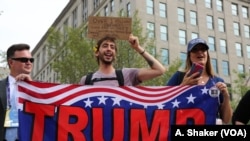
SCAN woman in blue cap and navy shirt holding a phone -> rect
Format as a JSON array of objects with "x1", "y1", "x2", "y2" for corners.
[{"x1": 166, "y1": 38, "x2": 232, "y2": 124}]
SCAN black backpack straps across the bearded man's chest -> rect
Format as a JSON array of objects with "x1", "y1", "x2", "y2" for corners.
[{"x1": 85, "y1": 70, "x2": 124, "y2": 86}]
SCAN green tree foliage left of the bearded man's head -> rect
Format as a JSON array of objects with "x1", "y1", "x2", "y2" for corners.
[{"x1": 48, "y1": 28, "x2": 97, "y2": 83}]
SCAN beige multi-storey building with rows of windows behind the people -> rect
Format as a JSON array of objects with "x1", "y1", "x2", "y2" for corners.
[{"x1": 32, "y1": 0, "x2": 250, "y2": 88}]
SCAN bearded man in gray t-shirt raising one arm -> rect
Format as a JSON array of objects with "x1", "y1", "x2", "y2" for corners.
[{"x1": 79, "y1": 34, "x2": 166, "y2": 86}]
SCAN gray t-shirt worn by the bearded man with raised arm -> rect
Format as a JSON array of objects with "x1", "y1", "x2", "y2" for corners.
[{"x1": 79, "y1": 68, "x2": 141, "y2": 86}]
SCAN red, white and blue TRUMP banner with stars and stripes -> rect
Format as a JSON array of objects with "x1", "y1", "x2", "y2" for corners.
[{"x1": 18, "y1": 81, "x2": 219, "y2": 141}]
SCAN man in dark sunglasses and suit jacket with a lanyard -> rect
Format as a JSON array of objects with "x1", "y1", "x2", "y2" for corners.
[{"x1": 0, "y1": 43, "x2": 34, "y2": 141}]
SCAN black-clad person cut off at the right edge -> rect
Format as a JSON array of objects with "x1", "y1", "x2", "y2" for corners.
[{"x1": 232, "y1": 90, "x2": 250, "y2": 125}]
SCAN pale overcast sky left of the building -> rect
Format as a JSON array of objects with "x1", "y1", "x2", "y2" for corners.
[{"x1": 0, "y1": 0, "x2": 69, "y2": 66}]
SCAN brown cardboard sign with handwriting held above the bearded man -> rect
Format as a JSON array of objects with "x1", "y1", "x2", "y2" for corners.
[{"x1": 88, "y1": 16, "x2": 132, "y2": 40}]
